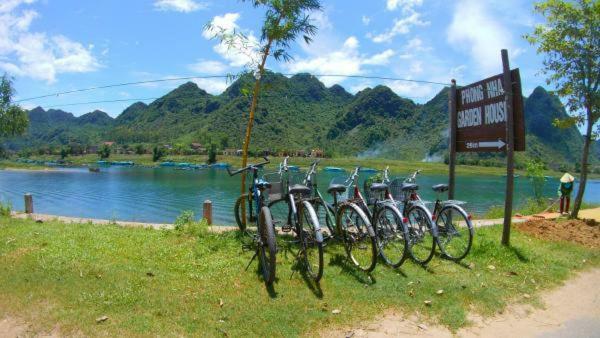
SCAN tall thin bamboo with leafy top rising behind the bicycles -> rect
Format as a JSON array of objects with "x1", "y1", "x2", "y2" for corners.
[{"x1": 205, "y1": 0, "x2": 321, "y2": 227}]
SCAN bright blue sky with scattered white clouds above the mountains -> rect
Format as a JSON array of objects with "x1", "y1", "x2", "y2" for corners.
[{"x1": 0, "y1": 0, "x2": 545, "y2": 116}]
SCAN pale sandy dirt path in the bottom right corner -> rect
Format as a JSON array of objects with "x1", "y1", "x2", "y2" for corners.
[{"x1": 322, "y1": 269, "x2": 600, "y2": 338}]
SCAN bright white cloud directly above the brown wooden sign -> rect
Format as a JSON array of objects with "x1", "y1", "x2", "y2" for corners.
[{"x1": 447, "y1": 0, "x2": 513, "y2": 76}]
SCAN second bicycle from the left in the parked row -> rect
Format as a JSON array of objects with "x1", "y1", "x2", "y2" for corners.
[{"x1": 265, "y1": 157, "x2": 324, "y2": 283}]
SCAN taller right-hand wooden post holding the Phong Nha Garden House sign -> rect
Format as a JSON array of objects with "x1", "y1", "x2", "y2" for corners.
[{"x1": 501, "y1": 49, "x2": 515, "y2": 246}]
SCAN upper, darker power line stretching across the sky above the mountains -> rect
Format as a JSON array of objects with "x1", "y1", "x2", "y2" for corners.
[{"x1": 14, "y1": 74, "x2": 449, "y2": 103}]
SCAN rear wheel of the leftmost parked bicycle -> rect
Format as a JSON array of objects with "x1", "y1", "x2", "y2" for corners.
[{"x1": 258, "y1": 207, "x2": 277, "y2": 285}]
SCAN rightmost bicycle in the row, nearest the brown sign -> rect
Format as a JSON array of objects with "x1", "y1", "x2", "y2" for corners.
[{"x1": 390, "y1": 170, "x2": 475, "y2": 261}]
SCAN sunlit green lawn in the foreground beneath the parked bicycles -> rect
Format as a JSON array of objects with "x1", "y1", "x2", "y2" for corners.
[{"x1": 0, "y1": 217, "x2": 600, "y2": 336}]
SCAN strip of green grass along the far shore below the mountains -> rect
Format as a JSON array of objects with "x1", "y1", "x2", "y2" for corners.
[{"x1": 0, "y1": 154, "x2": 560, "y2": 176}]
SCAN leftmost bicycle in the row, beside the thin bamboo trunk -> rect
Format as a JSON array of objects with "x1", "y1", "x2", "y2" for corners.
[{"x1": 227, "y1": 157, "x2": 277, "y2": 285}]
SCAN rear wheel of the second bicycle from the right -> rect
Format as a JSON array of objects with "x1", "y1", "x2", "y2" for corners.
[{"x1": 406, "y1": 205, "x2": 435, "y2": 264}]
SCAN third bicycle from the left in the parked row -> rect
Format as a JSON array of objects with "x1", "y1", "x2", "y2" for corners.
[{"x1": 306, "y1": 161, "x2": 378, "y2": 273}]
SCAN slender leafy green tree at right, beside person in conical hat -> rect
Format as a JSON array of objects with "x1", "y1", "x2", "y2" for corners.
[{"x1": 525, "y1": 0, "x2": 600, "y2": 218}]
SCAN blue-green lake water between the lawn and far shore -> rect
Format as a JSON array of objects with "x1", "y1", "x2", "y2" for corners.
[{"x1": 0, "y1": 166, "x2": 600, "y2": 224}]
